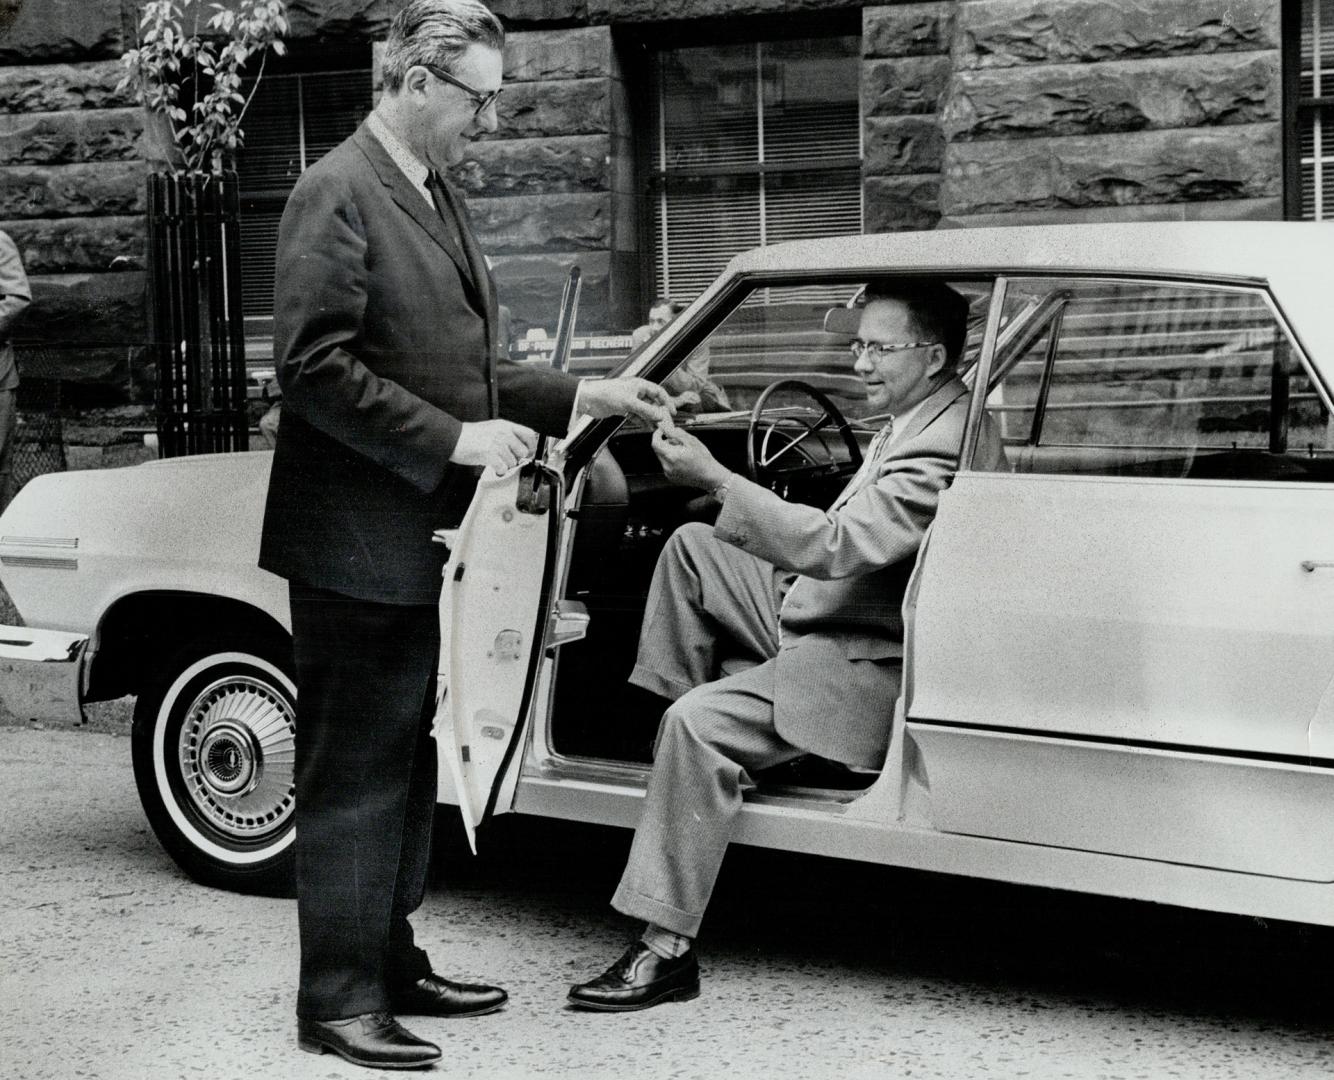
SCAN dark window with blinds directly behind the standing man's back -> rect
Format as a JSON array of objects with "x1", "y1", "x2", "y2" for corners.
[{"x1": 236, "y1": 63, "x2": 371, "y2": 321}]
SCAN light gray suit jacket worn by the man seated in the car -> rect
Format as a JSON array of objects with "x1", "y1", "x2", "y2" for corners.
[{"x1": 714, "y1": 379, "x2": 1001, "y2": 768}]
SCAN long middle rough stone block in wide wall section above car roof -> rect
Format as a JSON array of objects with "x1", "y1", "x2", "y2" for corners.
[{"x1": 940, "y1": 52, "x2": 1282, "y2": 141}]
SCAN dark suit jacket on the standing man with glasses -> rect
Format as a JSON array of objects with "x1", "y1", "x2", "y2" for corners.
[{"x1": 259, "y1": 124, "x2": 576, "y2": 604}]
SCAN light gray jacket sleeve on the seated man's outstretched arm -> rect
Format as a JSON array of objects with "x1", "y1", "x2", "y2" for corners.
[{"x1": 714, "y1": 418, "x2": 958, "y2": 581}]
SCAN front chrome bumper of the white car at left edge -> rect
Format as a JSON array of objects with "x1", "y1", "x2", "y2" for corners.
[{"x1": 0, "y1": 627, "x2": 88, "y2": 724}]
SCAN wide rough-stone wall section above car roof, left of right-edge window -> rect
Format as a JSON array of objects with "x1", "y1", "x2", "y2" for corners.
[{"x1": 940, "y1": 0, "x2": 1283, "y2": 224}]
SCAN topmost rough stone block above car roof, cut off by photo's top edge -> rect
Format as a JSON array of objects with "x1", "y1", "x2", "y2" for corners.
[{"x1": 955, "y1": 0, "x2": 1281, "y2": 71}]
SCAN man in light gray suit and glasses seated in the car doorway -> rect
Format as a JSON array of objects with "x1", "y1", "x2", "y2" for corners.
[{"x1": 570, "y1": 277, "x2": 1001, "y2": 1011}]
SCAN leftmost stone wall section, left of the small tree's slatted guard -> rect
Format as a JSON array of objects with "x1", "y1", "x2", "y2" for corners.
[{"x1": 0, "y1": 0, "x2": 152, "y2": 416}]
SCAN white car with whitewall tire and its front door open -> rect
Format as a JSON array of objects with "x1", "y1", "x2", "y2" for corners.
[{"x1": 0, "y1": 223, "x2": 1334, "y2": 925}]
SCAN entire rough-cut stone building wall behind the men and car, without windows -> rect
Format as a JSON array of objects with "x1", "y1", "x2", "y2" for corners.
[{"x1": 0, "y1": 0, "x2": 1301, "y2": 413}]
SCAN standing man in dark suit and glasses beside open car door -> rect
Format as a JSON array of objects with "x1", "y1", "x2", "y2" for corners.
[{"x1": 259, "y1": 0, "x2": 668, "y2": 1068}]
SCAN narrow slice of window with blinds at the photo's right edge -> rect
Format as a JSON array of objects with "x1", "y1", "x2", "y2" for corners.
[{"x1": 1297, "y1": 0, "x2": 1334, "y2": 221}]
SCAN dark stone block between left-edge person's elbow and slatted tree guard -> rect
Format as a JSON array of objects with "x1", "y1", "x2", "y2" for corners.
[{"x1": 23, "y1": 271, "x2": 148, "y2": 345}]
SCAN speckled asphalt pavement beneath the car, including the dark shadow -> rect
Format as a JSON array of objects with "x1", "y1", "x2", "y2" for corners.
[{"x1": 0, "y1": 725, "x2": 1334, "y2": 1080}]
